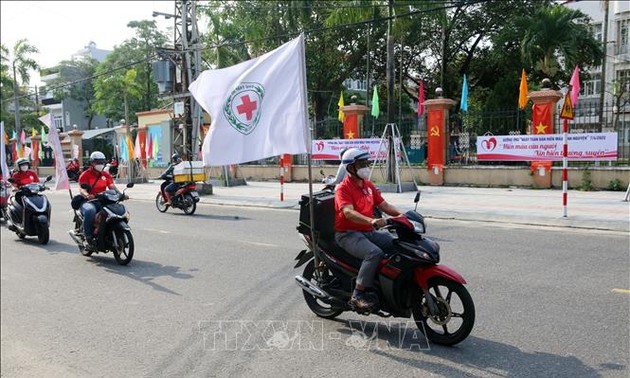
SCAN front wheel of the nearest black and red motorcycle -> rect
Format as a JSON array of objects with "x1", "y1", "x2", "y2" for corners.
[{"x1": 412, "y1": 277, "x2": 475, "y2": 345}]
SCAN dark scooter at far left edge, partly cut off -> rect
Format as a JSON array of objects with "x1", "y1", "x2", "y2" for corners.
[{"x1": 5, "y1": 176, "x2": 52, "y2": 244}]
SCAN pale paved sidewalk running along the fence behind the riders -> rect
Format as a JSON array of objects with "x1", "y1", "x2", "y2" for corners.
[{"x1": 110, "y1": 181, "x2": 630, "y2": 232}]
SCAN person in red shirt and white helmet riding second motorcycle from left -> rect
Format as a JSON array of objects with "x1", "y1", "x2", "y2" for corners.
[{"x1": 79, "y1": 151, "x2": 128, "y2": 245}]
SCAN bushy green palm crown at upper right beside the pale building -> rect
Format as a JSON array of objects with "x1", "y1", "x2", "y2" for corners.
[{"x1": 519, "y1": 6, "x2": 604, "y2": 81}]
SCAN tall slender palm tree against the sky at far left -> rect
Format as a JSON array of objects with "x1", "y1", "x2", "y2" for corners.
[{"x1": 2, "y1": 39, "x2": 39, "y2": 133}]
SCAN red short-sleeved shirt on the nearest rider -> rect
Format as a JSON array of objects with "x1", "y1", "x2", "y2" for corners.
[{"x1": 335, "y1": 175, "x2": 384, "y2": 231}]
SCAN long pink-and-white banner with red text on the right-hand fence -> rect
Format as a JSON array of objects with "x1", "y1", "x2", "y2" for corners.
[{"x1": 477, "y1": 133, "x2": 617, "y2": 161}]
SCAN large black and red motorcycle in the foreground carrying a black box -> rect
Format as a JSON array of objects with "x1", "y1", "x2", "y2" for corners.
[{"x1": 295, "y1": 191, "x2": 475, "y2": 345}]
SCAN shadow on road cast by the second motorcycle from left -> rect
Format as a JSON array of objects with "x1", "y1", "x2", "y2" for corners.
[{"x1": 91, "y1": 253, "x2": 194, "y2": 295}]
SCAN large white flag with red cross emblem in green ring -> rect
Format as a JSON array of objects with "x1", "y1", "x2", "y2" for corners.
[{"x1": 188, "y1": 35, "x2": 309, "y2": 166}]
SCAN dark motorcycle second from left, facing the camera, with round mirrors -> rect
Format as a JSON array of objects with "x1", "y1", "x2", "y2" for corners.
[{"x1": 68, "y1": 182, "x2": 135, "y2": 265}]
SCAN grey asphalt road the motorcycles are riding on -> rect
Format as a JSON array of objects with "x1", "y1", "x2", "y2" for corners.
[{"x1": 0, "y1": 192, "x2": 630, "y2": 377}]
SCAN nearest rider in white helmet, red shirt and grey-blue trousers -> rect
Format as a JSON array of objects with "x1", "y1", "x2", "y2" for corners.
[{"x1": 335, "y1": 148, "x2": 401, "y2": 309}]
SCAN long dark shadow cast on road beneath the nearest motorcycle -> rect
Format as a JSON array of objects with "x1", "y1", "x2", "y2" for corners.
[{"x1": 337, "y1": 320, "x2": 612, "y2": 377}]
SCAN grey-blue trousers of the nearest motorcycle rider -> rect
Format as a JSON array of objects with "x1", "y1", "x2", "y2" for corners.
[{"x1": 335, "y1": 231, "x2": 394, "y2": 287}]
